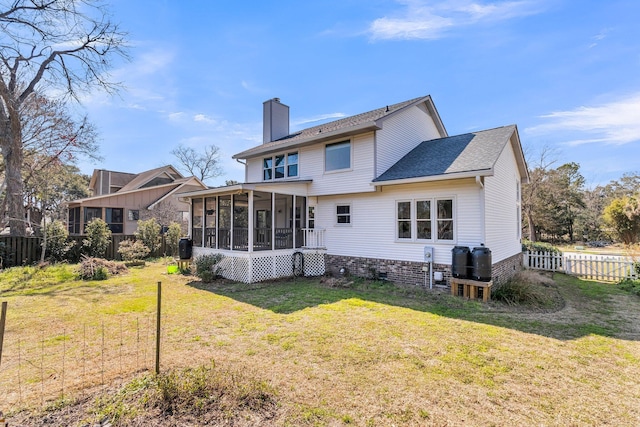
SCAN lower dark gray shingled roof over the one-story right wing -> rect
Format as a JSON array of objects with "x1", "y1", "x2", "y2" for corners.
[{"x1": 373, "y1": 125, "x2": 516, "y2": 182}]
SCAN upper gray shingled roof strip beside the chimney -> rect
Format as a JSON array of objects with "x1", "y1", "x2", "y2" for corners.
[{"x1": 233, "y1": 96, "x2": 428, "y2": 158}]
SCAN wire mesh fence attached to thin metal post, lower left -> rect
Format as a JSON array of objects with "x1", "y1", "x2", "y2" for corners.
[{"x1": 0, "y1": 313, "x2": 162, "y2": 412}]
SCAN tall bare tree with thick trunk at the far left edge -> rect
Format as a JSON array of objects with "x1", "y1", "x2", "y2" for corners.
[{"x1": 0, "y1": 0, "x2": 126, "y2": 235}]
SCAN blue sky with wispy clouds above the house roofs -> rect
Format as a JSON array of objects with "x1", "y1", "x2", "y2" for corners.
[{"x1": 80, "y1": 0, "x2": 640, "y2": 186}]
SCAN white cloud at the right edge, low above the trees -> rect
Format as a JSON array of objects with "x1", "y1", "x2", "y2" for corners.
[{"x1": 526, "y1": 92, "x2": 640, "y2": 145}]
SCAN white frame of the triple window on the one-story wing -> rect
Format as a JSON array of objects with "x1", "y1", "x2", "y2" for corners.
[{"x1": 394, "y1": 196, "x2": 458, "y2": 243}]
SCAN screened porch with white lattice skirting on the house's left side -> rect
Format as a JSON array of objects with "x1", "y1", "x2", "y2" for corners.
[{"x1": 181, "y1": 182, "x2": 324, "y2": 283}]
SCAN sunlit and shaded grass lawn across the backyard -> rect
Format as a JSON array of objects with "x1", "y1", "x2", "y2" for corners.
[{"x1": 0, "y1": 263, "x2": 640, "y2": 426}]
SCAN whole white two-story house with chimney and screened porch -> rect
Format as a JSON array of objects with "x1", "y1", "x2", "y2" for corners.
[{"x1": 181, "y1": 96, "x2": 528, "y2": 285}]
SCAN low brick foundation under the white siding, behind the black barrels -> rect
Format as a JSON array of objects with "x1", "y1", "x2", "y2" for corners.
[{"x1": 325, "y1": 254, "x2": 522, "y2": 289}]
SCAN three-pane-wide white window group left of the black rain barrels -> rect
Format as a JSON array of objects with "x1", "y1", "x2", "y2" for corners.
[{"x1": 396, "y1": 199, "x2": 455, "y2": 241}]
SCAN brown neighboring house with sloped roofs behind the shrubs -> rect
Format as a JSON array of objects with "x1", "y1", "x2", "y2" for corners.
[{"x1": 67, "y1": 165, "x2": 207, "y2": 235}]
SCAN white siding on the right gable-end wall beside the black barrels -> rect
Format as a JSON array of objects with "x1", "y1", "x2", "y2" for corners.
[{"x1": 484, "y1": 139, "x2": 522, "y2": 263}]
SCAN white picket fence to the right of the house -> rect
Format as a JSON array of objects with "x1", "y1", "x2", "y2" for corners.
[{"x1": 523, "y1": 251, "x2": 640, "y2": 282}]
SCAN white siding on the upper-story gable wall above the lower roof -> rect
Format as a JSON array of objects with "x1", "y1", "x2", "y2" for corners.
[{"x1": 375, "y1": 104, "x2": 441, "y2": 177}]
